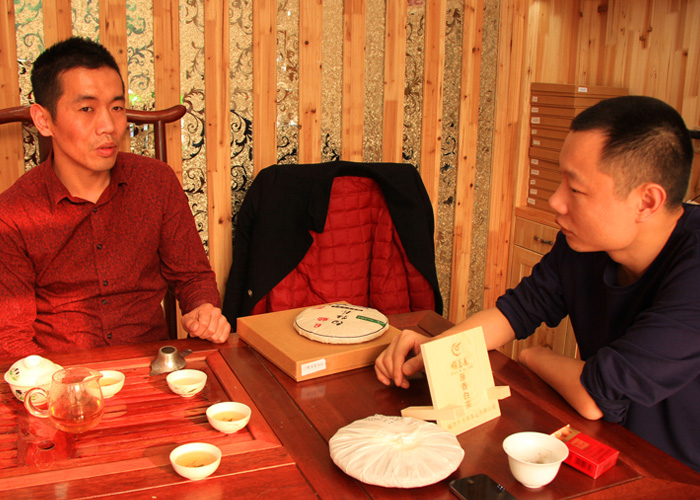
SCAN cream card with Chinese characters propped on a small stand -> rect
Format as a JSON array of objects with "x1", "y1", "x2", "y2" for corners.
[{"x1": 401, "y1": 327, "x2": 510, "y2": 434}]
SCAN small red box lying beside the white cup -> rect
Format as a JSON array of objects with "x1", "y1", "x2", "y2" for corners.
[{"x1": 553, "y1": 425, "x2": 620, "y2": 479}]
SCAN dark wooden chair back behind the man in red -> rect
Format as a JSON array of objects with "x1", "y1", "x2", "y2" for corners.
[{"x1": 0, "y1": 104, "x2": 187, "y2": 339}]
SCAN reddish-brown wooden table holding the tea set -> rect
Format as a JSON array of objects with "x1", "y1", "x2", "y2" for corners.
[{"x1": 0, "y1": 313, "x2": 700, "y2": 500}]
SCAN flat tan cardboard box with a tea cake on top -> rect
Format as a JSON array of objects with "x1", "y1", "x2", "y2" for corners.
[{"x1": 237, "y1": 307, "x2": 401, "y2": 382}]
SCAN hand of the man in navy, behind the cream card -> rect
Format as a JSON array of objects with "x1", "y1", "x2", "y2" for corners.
[{"x1": 374, "y1": 330, "x2": 430, "y2": 389}]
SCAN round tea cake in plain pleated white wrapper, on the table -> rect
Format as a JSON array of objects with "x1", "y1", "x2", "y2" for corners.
[{"x1": 328, "y1": 415, "x2": 464, "y2": 488}]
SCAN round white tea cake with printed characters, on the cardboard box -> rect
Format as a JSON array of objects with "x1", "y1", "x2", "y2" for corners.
[{"x1": 294, "y1": 304, "x2": 389, "y2": 344}]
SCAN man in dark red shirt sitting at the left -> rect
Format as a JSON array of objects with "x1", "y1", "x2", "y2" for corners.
[{"x1": 0, "y1": 38, "x2": 231, "y2": 356}]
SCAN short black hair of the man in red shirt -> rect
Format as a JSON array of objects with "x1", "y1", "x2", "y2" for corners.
[{"x1": 31, "y1": 37, "x2": 124, "y2": 117}]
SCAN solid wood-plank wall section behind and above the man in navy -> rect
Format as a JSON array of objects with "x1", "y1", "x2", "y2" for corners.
[{"x1": 483, "y1": 0, "x2": 700, "y2": 307}]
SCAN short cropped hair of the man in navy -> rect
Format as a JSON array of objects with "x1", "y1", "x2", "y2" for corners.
[{"x1": 571, "y1": 96, "x2": 694, "y2": 207}]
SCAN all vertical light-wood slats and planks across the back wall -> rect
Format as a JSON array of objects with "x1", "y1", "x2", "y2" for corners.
[{"x1": 0, "y1": 0, "x2": 700, "y2": 321}]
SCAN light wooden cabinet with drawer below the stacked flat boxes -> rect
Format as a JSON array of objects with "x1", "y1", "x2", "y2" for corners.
[{"x1": 501, "y1": 217, "x2": 579, "y2": 360}]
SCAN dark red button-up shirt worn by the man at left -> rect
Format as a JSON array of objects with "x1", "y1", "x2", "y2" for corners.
[{"x1": 0, "y1": 153, "x2": 220, "y2": 356}]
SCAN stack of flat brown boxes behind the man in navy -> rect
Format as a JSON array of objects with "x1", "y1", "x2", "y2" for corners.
[{"x1": 527, "y1": 83, "x2": 627, "y2": 212}]
